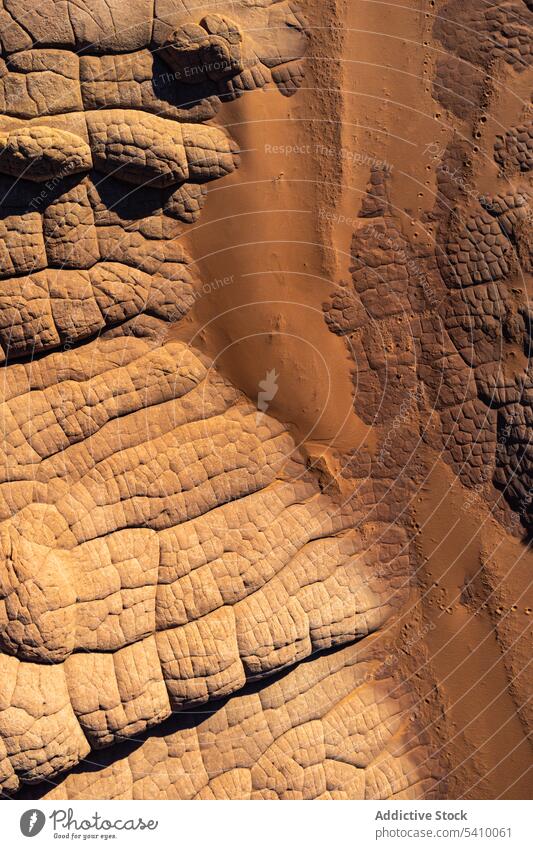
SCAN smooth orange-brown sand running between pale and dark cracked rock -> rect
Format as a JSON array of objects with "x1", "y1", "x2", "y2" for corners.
[{"x1": 173, "y1": 0, "x2": 532, "y2": 798}]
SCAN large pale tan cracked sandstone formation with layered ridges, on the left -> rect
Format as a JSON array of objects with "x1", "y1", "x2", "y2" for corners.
[{"x1": 0, "y1": 0, "x2": 436, "y2": 798}]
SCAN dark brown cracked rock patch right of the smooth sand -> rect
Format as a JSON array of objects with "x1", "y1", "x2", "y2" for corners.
[{"x1": 325, "y1": 0, "x2": 533, "y2": 536}]
